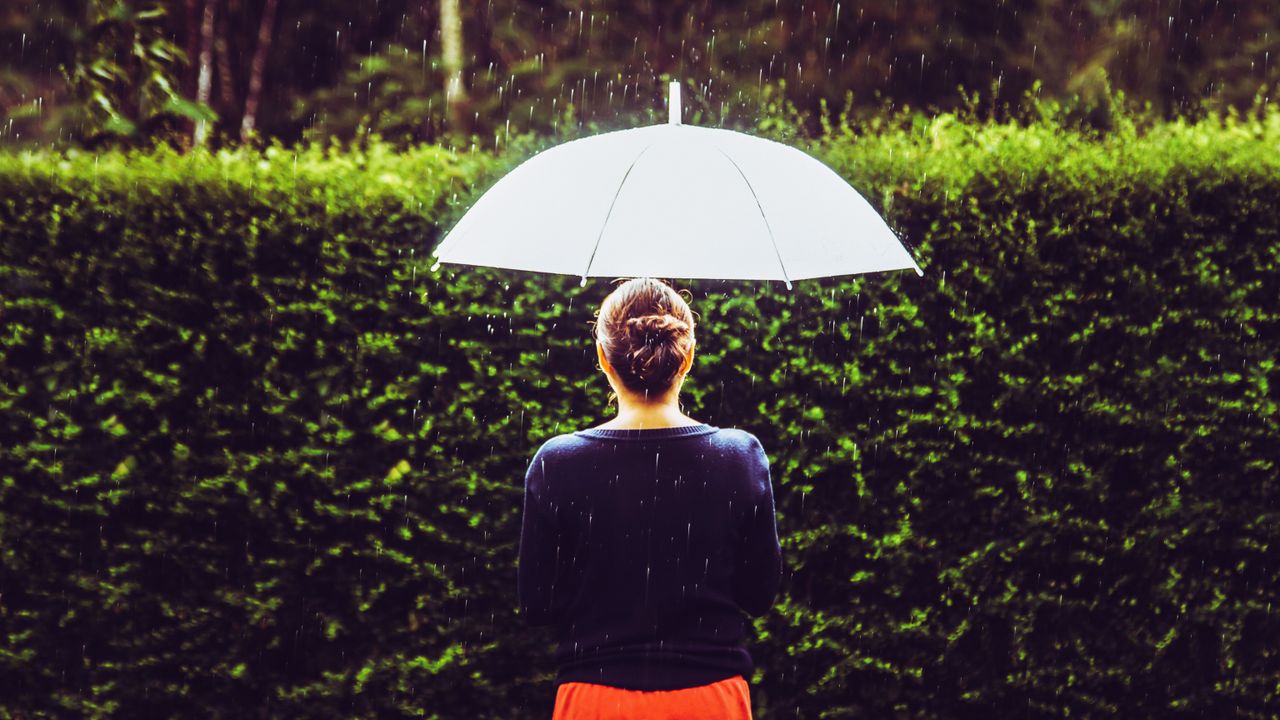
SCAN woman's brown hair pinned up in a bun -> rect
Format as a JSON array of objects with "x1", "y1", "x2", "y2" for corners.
[{"x1": 595, "y1": 278, "x2": 694, "y2": 400}]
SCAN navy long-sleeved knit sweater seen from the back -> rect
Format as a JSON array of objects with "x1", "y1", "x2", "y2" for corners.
[{"x1": 517, "y1": 424, "x2": 782, "y2": 691}]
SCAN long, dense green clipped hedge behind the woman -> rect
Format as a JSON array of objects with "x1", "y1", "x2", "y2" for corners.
[{"x1": 0, "y1": 115, "x2": 1280, "y2": 719}]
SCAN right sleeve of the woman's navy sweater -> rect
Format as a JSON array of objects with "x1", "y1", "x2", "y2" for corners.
[{"x1": 732, "y1": 436, "x2": 782, "y2": 616}]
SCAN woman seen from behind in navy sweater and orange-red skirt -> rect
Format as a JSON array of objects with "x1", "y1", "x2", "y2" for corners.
[{"x1": 517, "y1": 278, "x2": 782, "y2": 720}]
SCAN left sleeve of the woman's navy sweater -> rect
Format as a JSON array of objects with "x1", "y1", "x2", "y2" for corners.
[{"x1": 516, "y1": 443, "x2": 561, "y2": 625}]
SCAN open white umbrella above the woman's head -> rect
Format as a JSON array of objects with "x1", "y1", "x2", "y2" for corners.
[{"x1": 431, "y1": 82, "x2": 924, "y2": 290}]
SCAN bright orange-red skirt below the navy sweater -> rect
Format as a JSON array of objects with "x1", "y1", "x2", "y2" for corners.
[{"x1": 552, "y1": 675, "x2": 751, "y2": 720}]
